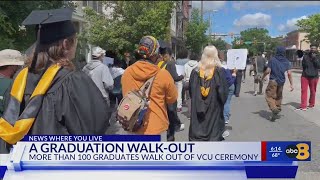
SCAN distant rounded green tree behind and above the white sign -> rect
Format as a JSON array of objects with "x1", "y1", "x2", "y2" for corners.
[{"x1": 232, "y1": 28, "x2": 272, "y2": 55}]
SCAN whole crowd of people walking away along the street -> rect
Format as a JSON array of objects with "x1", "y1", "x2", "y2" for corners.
[{"x1": 0, "y1": 9, "x2": 320, "y2": 152}]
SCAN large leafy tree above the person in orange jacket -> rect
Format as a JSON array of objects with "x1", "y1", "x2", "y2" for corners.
[{"x1": 82, "y1": 1, "x2": 174, "y2": 54}]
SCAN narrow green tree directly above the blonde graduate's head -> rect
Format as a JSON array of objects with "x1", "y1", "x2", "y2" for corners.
[{"x1": 186, "y1": 9, "x2": 209, "y2": 54}]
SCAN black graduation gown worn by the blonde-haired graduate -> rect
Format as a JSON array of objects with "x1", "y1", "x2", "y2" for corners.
[{"x1": 189, "y1": 68, "x2": 228, "y2": 141}]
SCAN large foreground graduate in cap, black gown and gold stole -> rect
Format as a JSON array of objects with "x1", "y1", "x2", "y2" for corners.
[{"x1": 0, "y1": 8, "x2": 111, "y2": 153}]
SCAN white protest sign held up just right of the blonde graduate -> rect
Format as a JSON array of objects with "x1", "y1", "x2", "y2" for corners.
[{"x1": 227, "y1": 49, "x2": 248, "y2": 70}]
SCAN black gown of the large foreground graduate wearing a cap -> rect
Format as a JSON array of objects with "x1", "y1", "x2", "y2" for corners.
[{"x1": 0, "y1": 69, "x2": 111, "y2": 153}]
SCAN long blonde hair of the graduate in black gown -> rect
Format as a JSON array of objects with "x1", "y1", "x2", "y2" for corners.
[{"x1": 199, "y1": 46, "x2": 222, "y2": 76}]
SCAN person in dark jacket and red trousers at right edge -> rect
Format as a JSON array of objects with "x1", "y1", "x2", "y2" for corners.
[{"x1": 297, "y1": 44, "x2": 320, "y2": 111}]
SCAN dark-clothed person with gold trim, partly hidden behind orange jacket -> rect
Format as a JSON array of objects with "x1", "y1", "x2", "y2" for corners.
[{"x1": 158, "y1": 44, "x2": 184, "y2": 141}]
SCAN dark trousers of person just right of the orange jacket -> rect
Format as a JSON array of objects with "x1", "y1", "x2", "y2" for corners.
[{"x1": 167, "y1": 101, "x2": 181, "y2": 141}]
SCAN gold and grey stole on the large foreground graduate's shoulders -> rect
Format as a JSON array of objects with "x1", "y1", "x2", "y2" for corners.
[{"x1": 0, "y1": 64, "x2": 61, "y2": 144}]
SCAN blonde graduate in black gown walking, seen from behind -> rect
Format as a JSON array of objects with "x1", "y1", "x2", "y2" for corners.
[{"x1": 189, "y1": 46, "x2": 228, "y2": 141}]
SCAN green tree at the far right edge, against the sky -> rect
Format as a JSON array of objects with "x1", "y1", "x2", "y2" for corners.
[{"x1": 297, "y1": 14, "x2": 320, "y2": 46}]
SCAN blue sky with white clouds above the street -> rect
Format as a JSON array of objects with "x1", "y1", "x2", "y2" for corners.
[{"x1": 192, "y1": 1, "x2": 320, "y2": 43}]
